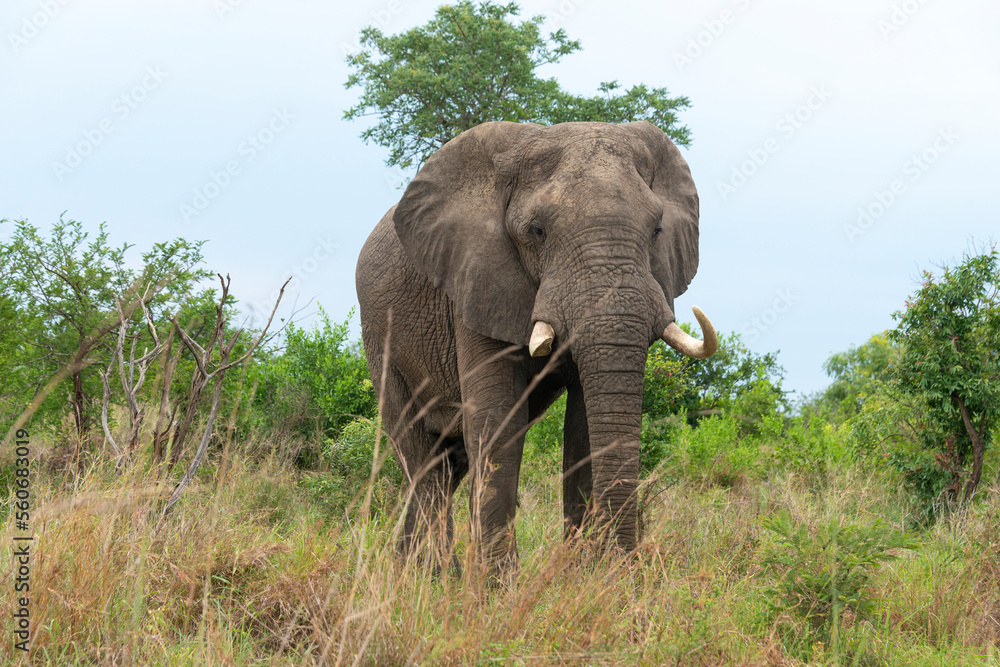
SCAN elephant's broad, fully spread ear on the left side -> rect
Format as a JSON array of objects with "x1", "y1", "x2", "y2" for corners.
[{"x1": 393, "y1": 122, "x2": 539, "y2": 345}]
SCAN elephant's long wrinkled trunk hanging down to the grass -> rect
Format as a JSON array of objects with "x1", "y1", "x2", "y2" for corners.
[{"x1": 573, "y1": 315, "x2": 649, "y2": 552}]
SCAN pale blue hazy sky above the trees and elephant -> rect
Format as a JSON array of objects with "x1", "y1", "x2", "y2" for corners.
[{"x1": 0, "y1": 0, "x2": 1000, "y2": 396}]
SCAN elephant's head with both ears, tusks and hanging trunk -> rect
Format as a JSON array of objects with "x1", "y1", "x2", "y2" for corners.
[{"x1": 394, "y1": 122, "x2": 716, "y2": 547}]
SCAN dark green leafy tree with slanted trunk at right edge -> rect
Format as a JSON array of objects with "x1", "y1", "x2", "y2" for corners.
[{"x1": 889, "y1": 246, "x2": 1000, "y2": 499}]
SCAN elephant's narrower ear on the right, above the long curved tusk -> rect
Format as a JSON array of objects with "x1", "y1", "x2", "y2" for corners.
[{"x1": 623, "y1": 121, "x2": 698, "y2": 311}]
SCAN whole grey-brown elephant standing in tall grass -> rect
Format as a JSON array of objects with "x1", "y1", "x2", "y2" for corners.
[{"x1": 356, "y1": 121, "x2": 718, "y2": 573}]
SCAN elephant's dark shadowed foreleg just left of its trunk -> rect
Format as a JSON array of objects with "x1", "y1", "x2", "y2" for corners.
[{"x1": 563, "y1": 382, "x2": 593, "y2": 537}]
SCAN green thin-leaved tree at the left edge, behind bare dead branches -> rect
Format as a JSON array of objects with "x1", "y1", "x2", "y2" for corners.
[{"x1": 0, "y1": 218, "x2": 208, "y2": 436}]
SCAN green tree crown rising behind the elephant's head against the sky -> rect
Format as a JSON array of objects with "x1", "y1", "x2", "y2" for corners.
[{"x1": 344, "y1": 0, "x2": 691, "y2": 168}]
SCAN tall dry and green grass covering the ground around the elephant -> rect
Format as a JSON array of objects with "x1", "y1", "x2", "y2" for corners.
[{"x1": 0, "y1": 426, "x2": 1000, "y2": 665}]
